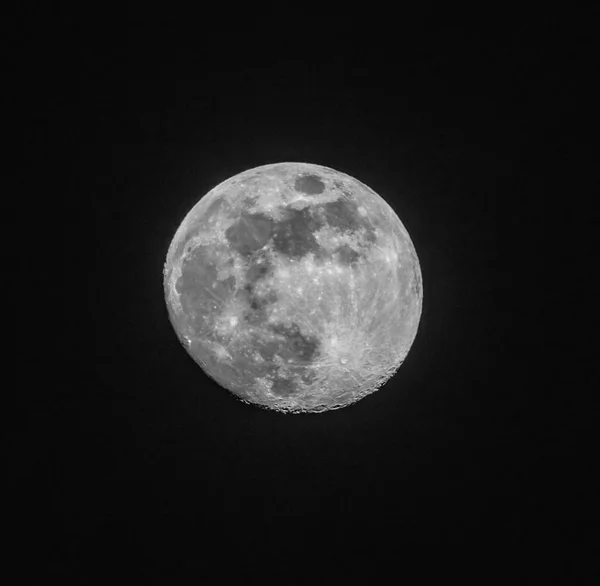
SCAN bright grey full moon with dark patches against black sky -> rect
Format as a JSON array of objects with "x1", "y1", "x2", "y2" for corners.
[{"x1": 163, "y1": 163, "x2": 423, "y2": 413}]
